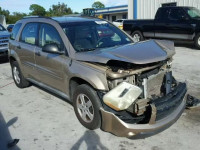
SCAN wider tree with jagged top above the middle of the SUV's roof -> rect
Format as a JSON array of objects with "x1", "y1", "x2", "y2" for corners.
[{"x1": 47, "y1": 3, "x2": 73, "y2": 16}]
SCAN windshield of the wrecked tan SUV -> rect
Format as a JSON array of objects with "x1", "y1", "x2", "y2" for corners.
[{"x1": 61, "y1": 21, "x2": 132, "y2": 52}]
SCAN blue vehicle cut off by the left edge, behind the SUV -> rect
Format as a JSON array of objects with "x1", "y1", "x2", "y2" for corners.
[{"x1": 0, "y1": 24, "x2": 10, "y2": 60}]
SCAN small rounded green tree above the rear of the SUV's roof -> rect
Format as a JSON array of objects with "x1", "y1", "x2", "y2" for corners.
[{"x1": 29, "y1": 4, "x2": 46, "y2": 16}]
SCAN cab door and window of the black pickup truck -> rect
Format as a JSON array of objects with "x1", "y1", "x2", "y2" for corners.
[{"x1": 155, "y1": 7, "x2": 194, "y2": 40}]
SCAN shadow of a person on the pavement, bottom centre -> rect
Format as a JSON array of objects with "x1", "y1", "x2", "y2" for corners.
[{"x1": 70, "y1": 130, "x2": 108, "y2": 150}]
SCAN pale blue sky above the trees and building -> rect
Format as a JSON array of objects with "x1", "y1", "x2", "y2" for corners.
[{"x1": 0, "y1": 0, "x2": 128, "y2": 13}]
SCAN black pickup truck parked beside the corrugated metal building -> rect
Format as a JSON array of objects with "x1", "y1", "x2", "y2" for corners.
[{"x1": 123, "y1": 7, "x2": 200, "y2": 49}]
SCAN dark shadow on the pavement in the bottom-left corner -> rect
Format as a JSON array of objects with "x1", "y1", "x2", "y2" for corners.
[{"x1": 0, "y1": 112, "x2": 20, "y2": 150}]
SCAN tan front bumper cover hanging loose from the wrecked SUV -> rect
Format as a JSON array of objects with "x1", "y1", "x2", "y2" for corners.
[{"x1": 101, "y1": 82, "x2": 186, "y2": 139}]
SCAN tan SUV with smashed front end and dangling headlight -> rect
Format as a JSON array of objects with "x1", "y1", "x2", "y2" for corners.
[{"x1": 9, "y1": 17, "x2": 187, "y2": 138}]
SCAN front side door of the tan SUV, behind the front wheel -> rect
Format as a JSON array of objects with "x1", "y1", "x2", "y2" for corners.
[{"x1": 35, "y1": 23, "x2": 66, "y2": 92}]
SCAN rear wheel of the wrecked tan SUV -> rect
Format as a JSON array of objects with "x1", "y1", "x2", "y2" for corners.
[{"x1": 11, "y1": 61, "x2": 30, "y2": 88}]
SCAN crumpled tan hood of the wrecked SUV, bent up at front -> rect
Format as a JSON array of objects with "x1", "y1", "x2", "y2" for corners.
[{"x1": 75, "y1": 40, "x2": 175, "y2": 64}]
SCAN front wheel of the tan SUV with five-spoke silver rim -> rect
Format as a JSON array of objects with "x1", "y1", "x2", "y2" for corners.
[{"x1": 73, "y1": 84, "x2": 101, "y2": 130}]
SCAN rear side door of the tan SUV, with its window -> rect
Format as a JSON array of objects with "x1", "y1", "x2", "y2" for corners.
[{"x1": 16, "y1": 23, "x2": 39, "y2": 78}]
